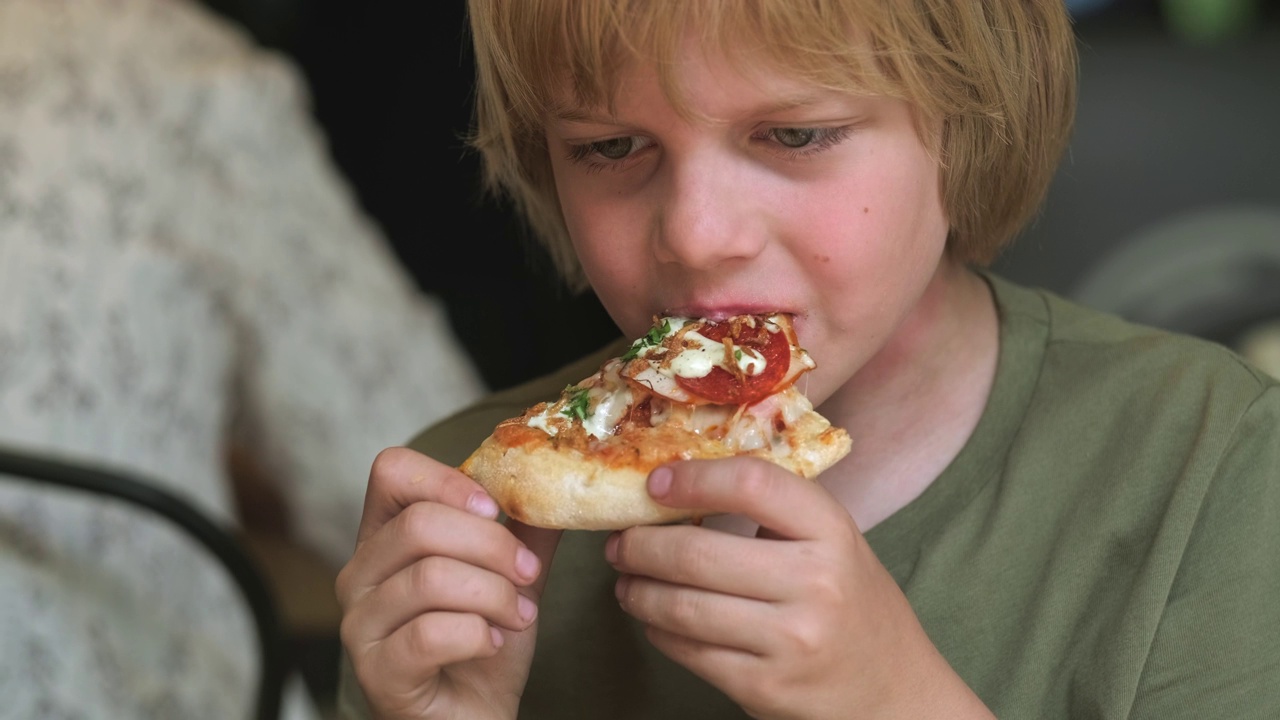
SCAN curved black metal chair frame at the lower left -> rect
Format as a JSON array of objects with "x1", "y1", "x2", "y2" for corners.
[{"x1": 0, "y1": 447, "x2": 287, "y2": 720}]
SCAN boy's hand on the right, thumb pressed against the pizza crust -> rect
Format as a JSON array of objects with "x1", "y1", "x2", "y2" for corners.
[{"x1": 605, "y1": 459, "x2": 991, "y2": 719}]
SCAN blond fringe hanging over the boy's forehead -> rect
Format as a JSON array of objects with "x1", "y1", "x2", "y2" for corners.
[{"x1": 502, "y1": 0, "x2": 904, "y2": 128}]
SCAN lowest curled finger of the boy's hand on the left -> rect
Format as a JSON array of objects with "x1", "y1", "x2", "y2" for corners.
[{"x1": 358, "y1": 612, "x2": 502, "y2": 694}]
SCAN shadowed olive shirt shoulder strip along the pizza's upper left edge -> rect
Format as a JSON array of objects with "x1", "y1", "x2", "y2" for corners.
[{"x1": 408, "y1": 338, "x2": 626, "y2": 465}]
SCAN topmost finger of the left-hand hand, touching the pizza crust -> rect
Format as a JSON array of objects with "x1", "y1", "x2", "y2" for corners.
[{"x1": 356, "y1": 447, "x2": 498, "y2": 546}]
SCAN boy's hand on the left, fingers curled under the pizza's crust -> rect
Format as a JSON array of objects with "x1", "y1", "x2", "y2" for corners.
[{"x1": 335, "y1": 447, "x2": 561, "y2": 719}]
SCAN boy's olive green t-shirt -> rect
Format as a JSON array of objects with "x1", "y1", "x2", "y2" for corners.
[{"x1": 335, "y1": 271, "x2": 1280, "y2": 720}]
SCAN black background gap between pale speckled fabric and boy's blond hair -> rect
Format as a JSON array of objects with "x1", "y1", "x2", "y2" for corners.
[{"x1": 197, "y1": 0, "x2": 617, "y2": 388}]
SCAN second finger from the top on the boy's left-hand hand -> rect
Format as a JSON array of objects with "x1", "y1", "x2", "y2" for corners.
[{"x1": 337, "y1": 502, "x2": 539, "y2": 606}]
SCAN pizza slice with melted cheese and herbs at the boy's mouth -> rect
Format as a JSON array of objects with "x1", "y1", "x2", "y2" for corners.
[{"x1": 461, "y1": 314, "x2": 851, "y2": 529}]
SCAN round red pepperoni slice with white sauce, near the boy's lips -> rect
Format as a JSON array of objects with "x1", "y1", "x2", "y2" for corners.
[{"x1": 676, "y1": 322, "x2": 791, "y2": 405}]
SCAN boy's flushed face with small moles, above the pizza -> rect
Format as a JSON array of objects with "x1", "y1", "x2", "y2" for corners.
[{"x1": 547, "y1": 46, "x2": 947, "y2": 405}]
